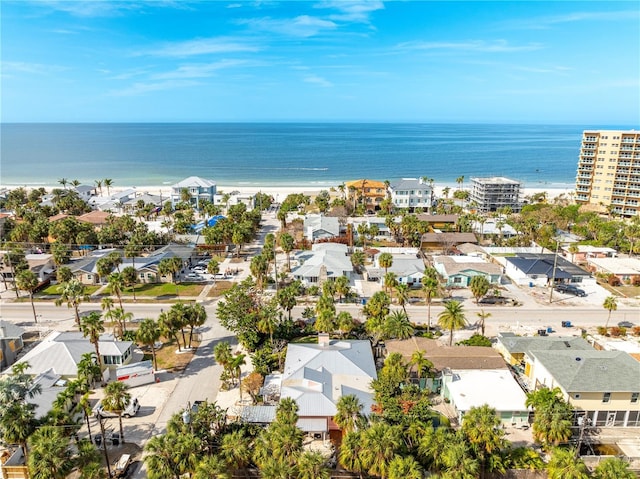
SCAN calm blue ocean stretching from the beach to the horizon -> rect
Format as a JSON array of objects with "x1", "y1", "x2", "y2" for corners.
[{"x1": 0, "y1": 123, "x2": 616, "y2": 188}]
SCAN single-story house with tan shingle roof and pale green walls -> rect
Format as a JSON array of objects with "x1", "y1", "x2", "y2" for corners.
[{"x1": 433, "y1": 256, "x2": 502, "y2": 288}]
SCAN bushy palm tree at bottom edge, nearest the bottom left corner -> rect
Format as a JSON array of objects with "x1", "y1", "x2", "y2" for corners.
[{"x1": 28, "y1": 426, "x2": 73, "y2": 479}]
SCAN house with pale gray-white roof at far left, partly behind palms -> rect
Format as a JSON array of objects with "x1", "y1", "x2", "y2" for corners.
[{"x1": 8, "y1": 331, "x2": 134, "y2": 380}]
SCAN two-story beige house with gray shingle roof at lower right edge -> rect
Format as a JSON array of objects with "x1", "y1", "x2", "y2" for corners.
[{"x1": 531, "y1": 349, "x2": 640, "y2": 427}]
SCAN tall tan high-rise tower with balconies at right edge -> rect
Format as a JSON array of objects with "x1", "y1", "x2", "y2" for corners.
[{"x1": 575, "y1": 130, "x2": 640, "y2": 217}]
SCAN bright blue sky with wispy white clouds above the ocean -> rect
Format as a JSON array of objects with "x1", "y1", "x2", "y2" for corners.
[{"x1": 0, "y1": 0, "x2": 640, "y2": 127}]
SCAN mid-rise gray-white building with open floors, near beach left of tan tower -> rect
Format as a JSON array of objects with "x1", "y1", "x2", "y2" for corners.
[{"x1": 469, "y1": 176, "x2": 522, "y2": 213}]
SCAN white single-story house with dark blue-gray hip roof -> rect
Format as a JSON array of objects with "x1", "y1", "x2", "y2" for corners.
[{"x1": 504, "y1": 253, "x2": 594, "y2": 286}]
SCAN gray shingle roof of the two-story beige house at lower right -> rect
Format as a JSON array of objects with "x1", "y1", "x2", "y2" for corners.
[{"x1": 532, "y1": 349, "x2": 640, "y2": 393}]
